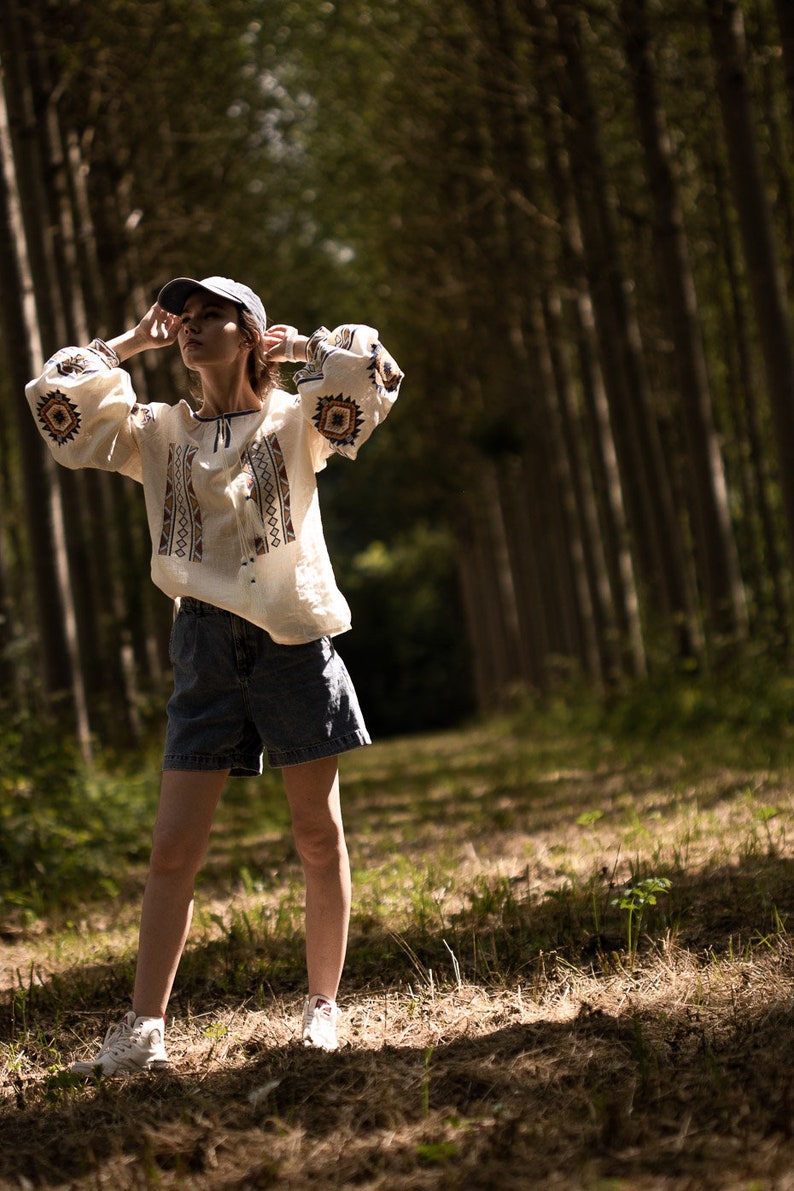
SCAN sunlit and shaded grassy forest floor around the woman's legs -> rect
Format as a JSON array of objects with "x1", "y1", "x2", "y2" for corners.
[{"x1": 0, "y1": 718, "x2": 794, "y2": 1191}]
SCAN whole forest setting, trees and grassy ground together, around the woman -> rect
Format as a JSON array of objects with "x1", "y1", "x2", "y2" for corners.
[{"x1": 10, "y1": 0, "x2": 794, "y2": 1191}]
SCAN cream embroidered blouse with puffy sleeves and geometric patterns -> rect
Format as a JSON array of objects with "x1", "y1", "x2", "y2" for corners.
[{"x1": 26, "y1": 324, "x2": 402, "y2": 644}]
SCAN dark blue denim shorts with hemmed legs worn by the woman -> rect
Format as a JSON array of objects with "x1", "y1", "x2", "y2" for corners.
[{"x1": 163, "y1": 598, "x2": 370, "y2": 777}]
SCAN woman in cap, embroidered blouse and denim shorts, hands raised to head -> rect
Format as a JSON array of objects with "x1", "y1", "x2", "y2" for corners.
[{"x1": 27, "y1": 276, "x2": 402, "y2": 1075}]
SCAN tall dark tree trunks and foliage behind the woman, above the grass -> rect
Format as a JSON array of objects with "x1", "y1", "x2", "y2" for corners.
[{"x1": 0, "y1": 0, "x2": 794, "y2": 756}]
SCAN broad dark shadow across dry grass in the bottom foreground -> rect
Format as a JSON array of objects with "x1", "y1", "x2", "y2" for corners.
[{"x1": 0, "y1": 1005, "x2": 794, "y2": 1191}]
